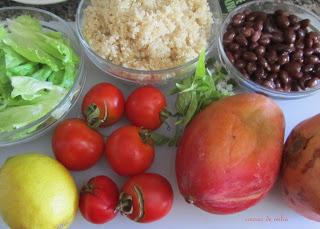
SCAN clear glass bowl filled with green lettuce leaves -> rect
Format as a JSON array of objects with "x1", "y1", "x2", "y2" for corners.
[{"x1": 0, "y1": 7, "x2": 85, "y2": 147}]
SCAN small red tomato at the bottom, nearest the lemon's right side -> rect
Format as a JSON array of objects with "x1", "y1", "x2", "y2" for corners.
[{"x1": 79, "y1": 176, "x2": 119, "y2": 224}]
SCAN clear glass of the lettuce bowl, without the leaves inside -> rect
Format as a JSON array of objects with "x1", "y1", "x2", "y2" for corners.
[{"x1": 0, "y1": 7, "x2": 85, "y2": 147}]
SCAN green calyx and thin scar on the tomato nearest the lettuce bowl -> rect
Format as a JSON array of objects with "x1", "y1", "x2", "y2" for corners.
[{"x1": 85, "y1": 103, "x2": 108, "y2": 129}]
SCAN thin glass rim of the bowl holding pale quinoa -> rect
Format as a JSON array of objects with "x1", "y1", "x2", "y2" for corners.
[{"x1": 75, "y1": 0, "x2": 222, "y2": 75}]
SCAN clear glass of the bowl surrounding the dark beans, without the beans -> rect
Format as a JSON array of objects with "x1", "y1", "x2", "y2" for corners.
[{"x1": 218, "y1": 0, "x2": 320, "y2": 99}]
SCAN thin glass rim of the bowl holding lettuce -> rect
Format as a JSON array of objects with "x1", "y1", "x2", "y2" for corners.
[{"x1": 0, "y1": 6, "x2": 85, "y2": 137}]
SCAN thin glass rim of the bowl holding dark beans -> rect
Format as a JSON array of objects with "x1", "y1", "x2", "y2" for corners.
[{"x1": 218, "y1": 0, "x2": 320, "y2": 99}]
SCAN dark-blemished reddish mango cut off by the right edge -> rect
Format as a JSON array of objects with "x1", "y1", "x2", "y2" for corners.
[{"x1": 281, "y1": 114, "x2": 320, "y2": 221}]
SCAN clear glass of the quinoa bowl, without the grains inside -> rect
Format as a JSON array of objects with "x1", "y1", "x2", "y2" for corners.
[{"x1": 76, "y1": 0, "x2": 222, "y2": 85}]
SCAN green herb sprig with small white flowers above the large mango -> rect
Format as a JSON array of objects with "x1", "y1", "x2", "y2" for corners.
[{"x1": 171, "y1": 50, "x2": 233, "y2": 127}]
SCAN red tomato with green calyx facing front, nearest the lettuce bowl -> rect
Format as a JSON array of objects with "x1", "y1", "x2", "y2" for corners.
[{"x1": 82, "y1": 83, "x2": 125, "y2": 128}]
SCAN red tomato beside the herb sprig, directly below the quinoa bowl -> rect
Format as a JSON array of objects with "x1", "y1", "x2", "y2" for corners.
[{"x1": 126, "y1": 86, "x2": 167, "y2": 130}]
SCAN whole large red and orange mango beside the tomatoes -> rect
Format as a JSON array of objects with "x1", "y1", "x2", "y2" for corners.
[{"x1": 176, "y1": 94, "x2": 285, "y2": 214}]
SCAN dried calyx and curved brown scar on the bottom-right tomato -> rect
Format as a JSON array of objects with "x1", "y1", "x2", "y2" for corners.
[{"x1": 116, "y1": 185, "x2": 144, "y2": 222}]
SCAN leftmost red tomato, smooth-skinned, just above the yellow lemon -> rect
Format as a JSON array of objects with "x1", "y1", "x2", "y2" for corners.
[{"x1": 52, "y1": 119, "x2": 104, "y2": 170}]
